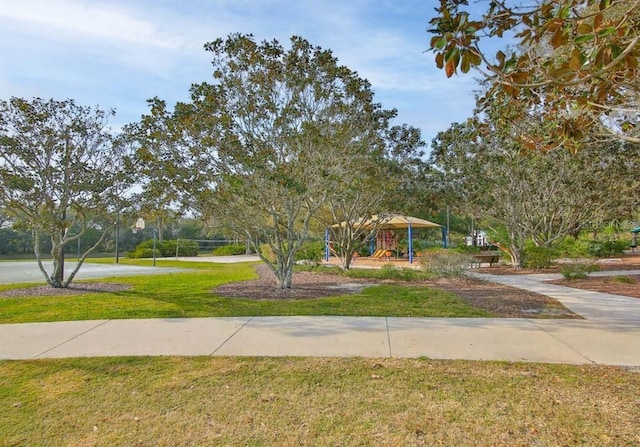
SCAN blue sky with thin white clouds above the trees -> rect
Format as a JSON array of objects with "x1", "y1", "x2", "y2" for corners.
[{"x1": 0, "y1": 0, "x2": 484, "y2": 147}]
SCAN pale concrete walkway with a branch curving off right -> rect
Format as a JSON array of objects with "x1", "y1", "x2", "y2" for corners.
[{"x1": 0, "y1": 271, "x2": 640, "y2": 367}]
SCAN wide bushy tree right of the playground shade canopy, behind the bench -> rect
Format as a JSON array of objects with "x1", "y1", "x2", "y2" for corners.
[{"x1": 431, "y1": 96, "x2": 640, "y2": 267}]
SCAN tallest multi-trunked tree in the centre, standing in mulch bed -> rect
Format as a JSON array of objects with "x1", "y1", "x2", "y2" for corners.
[{"x1": 130, "y1": 34, "x2": 430, "y2": 289}]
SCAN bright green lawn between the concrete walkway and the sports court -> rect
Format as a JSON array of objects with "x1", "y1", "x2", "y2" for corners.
[{"x1": 0, "y1": 259, "x2": 491, "y2": 323}]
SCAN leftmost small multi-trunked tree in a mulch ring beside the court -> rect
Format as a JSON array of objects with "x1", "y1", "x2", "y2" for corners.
[{"x1": 0, "y1": 98, "x2": 133, "y2": 287}]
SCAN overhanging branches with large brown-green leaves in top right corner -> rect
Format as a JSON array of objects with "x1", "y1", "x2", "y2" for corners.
[{"x1": 429, "y1": 0, "x2": 640, "y2": 149}]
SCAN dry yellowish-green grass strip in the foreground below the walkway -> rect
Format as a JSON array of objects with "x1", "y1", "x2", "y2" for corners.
[{"x1": 0, "y1": 357, "x2": 640, "y2": 446}]
